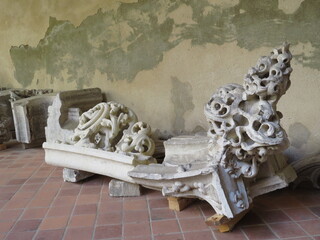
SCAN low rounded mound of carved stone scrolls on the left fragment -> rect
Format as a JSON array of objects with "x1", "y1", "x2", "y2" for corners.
[{"x1": 72, "y1": 102, "x2": 155, "y2": 157}]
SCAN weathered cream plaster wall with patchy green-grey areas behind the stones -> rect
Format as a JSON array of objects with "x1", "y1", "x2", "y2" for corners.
[{"x1": 0, "y1": 0, "x2": 320, "y2": 160}]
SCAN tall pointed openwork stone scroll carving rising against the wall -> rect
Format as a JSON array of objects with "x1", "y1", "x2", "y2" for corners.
[{"x1": 204, "y1": 43, "x2": 292, "y2": 178}]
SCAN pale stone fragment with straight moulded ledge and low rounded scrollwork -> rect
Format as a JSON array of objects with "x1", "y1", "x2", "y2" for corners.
[{"x1": 43, "y1": 100, "x2": 156, "y2": 183}]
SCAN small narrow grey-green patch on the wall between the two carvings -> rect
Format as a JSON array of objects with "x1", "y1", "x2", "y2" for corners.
[{"x1": 171, "y1": 77, "x2": 194, "y2": 130}]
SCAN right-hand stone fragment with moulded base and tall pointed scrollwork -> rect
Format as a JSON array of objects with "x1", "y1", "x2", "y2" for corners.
[{"x1": 128, "y1": 44, "x2": 295, "y2": 218}]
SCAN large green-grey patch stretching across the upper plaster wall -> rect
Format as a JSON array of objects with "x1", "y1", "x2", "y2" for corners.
[{"x1": 10, "y1": 0, "x2": 320, "y2": 88}]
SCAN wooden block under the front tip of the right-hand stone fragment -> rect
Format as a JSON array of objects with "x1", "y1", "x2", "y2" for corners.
[{"x1": 206, "y1": 209, "x2": 250, "y2": 233}]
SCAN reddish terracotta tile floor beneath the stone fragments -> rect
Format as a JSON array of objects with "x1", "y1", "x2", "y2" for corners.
[{"x1": 0, "y1": 146, "x2": 320, "y2": 240}]
